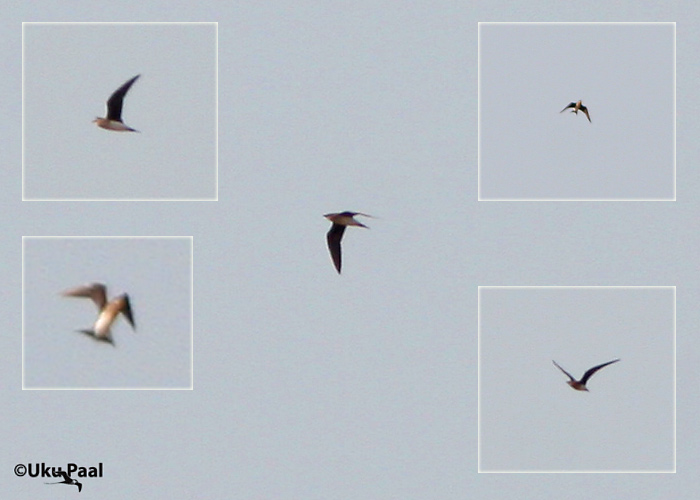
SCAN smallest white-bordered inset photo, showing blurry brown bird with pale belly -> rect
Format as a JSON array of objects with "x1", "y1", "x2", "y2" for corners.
[{"x1": 22, "y1": 236, "x2": 193, "y2": 390}]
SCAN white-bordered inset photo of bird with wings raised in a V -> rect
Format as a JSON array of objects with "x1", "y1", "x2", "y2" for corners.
[{"x1": 478, "y1": 286, "x2": 676, "y2": 473}]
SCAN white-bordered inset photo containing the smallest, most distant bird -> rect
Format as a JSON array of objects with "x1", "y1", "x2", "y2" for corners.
[{"x1": 478, "y1": 22, "x2": 676, "y2": 201}]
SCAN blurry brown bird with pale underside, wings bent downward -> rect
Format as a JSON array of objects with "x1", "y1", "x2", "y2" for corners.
[{"x1": 61, "y1": 283, "x2": 136, "y2": 345}]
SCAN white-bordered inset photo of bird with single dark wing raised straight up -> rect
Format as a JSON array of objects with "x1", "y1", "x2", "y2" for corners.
[{"x1": 22, "y1": 22, "x2": 218, "y2": 201}]
